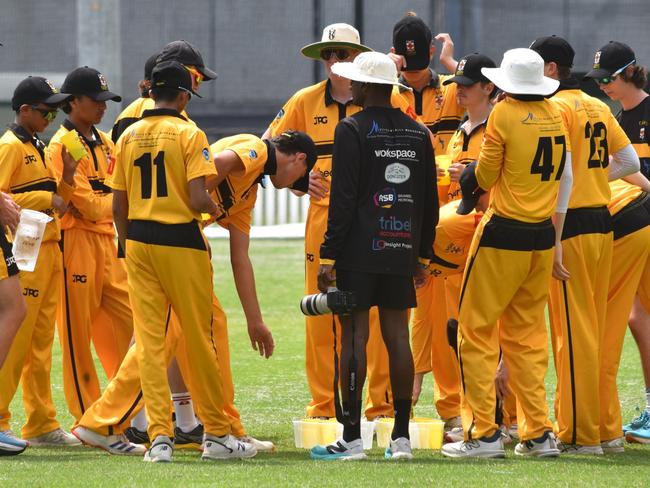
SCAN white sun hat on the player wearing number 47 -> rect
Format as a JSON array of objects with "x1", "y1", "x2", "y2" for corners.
[{"x1": 481, "y1": 48, "x2": 560, "y2": 96}]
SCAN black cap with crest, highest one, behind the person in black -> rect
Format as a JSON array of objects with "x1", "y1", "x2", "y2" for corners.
[{"x1": 393, "y1": 15, "x2": 432, "y2": 71}]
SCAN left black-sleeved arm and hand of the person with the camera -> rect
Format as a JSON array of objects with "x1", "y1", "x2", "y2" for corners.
[{"x1": 318, "y1": 122, "x2": 361, "y2": 291}]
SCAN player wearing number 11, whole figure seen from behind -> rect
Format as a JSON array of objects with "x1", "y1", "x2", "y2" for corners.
[{"x1": 109, "y1": 61, "x2": 257, "y2": 462}]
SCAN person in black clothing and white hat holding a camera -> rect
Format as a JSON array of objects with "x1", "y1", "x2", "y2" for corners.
[{"x1": 311, "y1": 52, "x2": 438, "y2": 459}]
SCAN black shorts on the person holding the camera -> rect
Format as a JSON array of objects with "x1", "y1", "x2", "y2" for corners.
[{"x1": 336, "y1": 269, "x2": 417, "y2": 310}]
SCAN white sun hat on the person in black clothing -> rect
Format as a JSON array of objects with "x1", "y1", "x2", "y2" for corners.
[{"x1": 332, "y1": 51, "x2": 410, "y2": 90}]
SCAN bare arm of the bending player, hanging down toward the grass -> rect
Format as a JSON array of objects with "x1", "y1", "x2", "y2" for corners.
[{"x1": 228, "y1": 224, "x2": 275, "y2": 358}]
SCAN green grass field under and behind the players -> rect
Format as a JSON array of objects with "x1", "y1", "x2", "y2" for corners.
[{"x1": 0, "y1": 241, "x2": 650, "y2": 488}]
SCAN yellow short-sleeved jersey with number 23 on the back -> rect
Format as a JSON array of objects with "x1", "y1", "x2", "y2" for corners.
[{"x1": 551, "y1": 89, "x2": 630, "y2": 208}]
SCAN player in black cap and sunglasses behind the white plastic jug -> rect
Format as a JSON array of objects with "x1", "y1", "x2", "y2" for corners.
[{"x1": 0, "y1": 76, "x2": 78, "y2": 446}]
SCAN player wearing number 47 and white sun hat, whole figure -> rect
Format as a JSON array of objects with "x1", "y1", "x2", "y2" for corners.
[{"x1": 442, "y1": 49, "x2": 571, "y2": 457}]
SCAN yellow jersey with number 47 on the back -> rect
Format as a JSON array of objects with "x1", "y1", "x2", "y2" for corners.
[{"x1": 476, "y1": 96, "x2": 570, "y2": 222}]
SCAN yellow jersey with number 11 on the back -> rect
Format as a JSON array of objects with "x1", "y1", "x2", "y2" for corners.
[{"x1": 107, "y1": 109, "x2": 217, "y2": 224}]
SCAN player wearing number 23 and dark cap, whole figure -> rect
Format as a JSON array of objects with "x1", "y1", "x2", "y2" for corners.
[{"x1": 531, "y1": 36, "x2": 639, "y2": 454}]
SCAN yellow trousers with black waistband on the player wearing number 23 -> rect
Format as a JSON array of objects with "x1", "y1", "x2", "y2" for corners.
[{"x1": 549, "y1": 207, "x2": 612, "y2": 446}]
